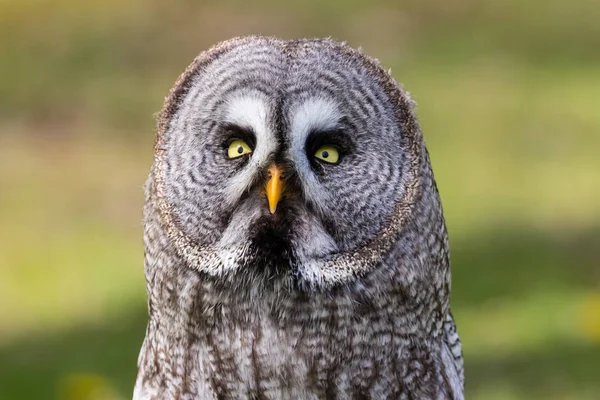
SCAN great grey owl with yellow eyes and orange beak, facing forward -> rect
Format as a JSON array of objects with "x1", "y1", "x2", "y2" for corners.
[{"x1": 134, "y1": 36, "x2": 463, "y2": 400}]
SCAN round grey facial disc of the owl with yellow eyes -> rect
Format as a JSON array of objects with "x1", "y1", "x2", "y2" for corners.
[{"x1": 154, "y1": 38, "x2": 414, "y2": 286}]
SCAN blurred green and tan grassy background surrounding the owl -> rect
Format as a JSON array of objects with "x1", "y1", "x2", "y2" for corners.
[{"x1": 0, "y1": 0, "x2": 600, "y2": 400}]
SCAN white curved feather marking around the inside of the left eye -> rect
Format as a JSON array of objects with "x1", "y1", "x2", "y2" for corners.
[{"x1": 224, "y1": 92, "x2": 277, "y2": 204}]
